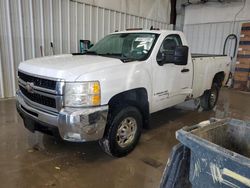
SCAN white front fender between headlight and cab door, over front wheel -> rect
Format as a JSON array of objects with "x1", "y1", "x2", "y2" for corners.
[{"x1": 77, "y1": 61, "x2": 152, "y2": 105}]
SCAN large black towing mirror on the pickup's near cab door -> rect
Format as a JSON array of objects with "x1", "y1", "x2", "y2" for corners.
[{"x1": 156, "y1": 46, "x2": 188, "y2": 66}]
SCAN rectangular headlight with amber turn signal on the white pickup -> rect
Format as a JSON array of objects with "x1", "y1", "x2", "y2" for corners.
[{"x1": 64, "y1": 81, "x2": 101, "y2": 107}]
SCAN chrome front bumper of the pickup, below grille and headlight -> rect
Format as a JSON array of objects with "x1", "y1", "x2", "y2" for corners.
[{"x1": 16, "y1": 91, "x2": 108, "y2": 142}]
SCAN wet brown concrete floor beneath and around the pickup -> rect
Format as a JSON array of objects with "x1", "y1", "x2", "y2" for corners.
[{"x1": 0, "y1": 89, "x2": 250, "y2": 188}]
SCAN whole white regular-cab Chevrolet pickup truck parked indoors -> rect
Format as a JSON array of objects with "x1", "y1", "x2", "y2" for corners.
[{"x1": 16, "y1": 30, "x2": 230, "y2": 157}]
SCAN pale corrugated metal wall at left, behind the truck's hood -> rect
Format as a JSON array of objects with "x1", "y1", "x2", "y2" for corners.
[{"x1": 0, "y1": 0, "x2": 171, "y2": 98}]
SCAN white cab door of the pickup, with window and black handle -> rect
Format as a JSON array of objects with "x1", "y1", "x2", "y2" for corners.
[{"x1": 153, "y1": 34, "x2": 192, "y2": 111}]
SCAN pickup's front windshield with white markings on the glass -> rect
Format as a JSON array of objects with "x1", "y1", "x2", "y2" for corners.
[{"x1": 86, "y1": 33, "x2": 158, "y2": 61}]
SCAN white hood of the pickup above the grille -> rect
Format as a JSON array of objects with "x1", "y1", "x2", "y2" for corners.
[{"x1": 19, "y1": 54, "x2": 123, "y2": 81}]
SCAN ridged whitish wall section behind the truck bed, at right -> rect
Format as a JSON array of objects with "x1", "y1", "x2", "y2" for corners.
[{"x1": 184, "y1": 21, "x2": 249, "y2": 60}]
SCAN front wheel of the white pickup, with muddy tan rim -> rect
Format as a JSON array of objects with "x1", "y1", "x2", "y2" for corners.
[{"x1": 99, "y1": 106, "x2": 142, "y2": 157}]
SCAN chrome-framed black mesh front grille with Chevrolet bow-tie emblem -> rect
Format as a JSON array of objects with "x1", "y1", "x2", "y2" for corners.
[{"x1": 18, "y1": 71, "x2": 64, "y2": 112}]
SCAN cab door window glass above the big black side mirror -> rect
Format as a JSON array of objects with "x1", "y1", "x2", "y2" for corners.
[{"x1": 158, "y1": 34, "x2": 182, "y2": 54}]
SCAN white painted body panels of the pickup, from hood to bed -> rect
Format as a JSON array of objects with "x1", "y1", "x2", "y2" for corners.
[{"x1": 19, "y1": 30, "x2": 230, "y2": 113}]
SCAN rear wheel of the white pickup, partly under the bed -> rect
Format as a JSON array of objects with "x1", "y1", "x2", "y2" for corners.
[{"x1": 201, "y1": 83, "x2": 220, "y2": 111}]
